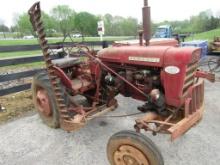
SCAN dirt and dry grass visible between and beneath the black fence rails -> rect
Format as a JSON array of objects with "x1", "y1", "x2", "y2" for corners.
[{"x1": 0, "y1": 65, "x2": 42, "y2": 124}]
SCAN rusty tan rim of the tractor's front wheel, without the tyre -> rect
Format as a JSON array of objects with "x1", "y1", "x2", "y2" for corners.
[{"x1": 114, "y1": 145, "x2": 149, "y2": 165}]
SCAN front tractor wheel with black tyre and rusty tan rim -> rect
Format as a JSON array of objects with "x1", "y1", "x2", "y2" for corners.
[{"x1": 107, "y1": 131, "x2": 164, "y2": 165}]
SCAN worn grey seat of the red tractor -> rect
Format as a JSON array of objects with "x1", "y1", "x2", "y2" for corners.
[{"x1": 52, "y1": 57, "x2": 81, "y2": 68}]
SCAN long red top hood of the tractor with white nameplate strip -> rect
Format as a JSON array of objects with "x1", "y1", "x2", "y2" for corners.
[{"x1": 98, "y1": 46, "x2": 201, "y2": 67}]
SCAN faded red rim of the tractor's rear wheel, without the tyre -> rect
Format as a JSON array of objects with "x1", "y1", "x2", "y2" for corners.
[{"x1": 37, "y1": 89, "x2": 52, "y2": 117}]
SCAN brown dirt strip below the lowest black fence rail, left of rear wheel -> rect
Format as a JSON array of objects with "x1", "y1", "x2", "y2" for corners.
[{"x1": 0, "y1": 90, "x2": 34, "y2": 123}]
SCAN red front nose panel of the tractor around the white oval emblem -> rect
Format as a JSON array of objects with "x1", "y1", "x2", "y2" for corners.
[{"x1": 163, "y1": 47, "x2": 200, "y2": 106}]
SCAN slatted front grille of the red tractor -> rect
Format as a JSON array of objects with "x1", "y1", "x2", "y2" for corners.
[{"x1": 183, "y1": 62, "x2": 198, "y2": 96}]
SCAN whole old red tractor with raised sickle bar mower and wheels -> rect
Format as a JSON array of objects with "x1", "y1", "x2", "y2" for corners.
[{"x1": 29, "y1": 0, "x2": 214, "y2": 165}]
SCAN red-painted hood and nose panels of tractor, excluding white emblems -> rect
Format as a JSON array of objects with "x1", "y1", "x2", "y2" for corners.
[{"x1": 98, "y1": 46, "x2": 201, "y2": 107}]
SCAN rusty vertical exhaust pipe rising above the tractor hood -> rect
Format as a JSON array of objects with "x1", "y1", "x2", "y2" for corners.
[{"x1": 142, "y1": 0, "x2": 151, "y2": 46}]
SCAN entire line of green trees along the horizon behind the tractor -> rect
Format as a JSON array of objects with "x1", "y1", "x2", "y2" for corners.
[{"x1": 0, "y1": 5, "x2": 220, "y2": 37}]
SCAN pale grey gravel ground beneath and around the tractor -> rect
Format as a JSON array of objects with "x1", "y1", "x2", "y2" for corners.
[{"x1": 0, "y1": 82, "x2": 220, "y2": 165}]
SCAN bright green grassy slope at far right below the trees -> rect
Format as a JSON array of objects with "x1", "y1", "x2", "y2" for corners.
[{"x1": 187, "y1": 28, "x2": 220, "y2": 42}]
